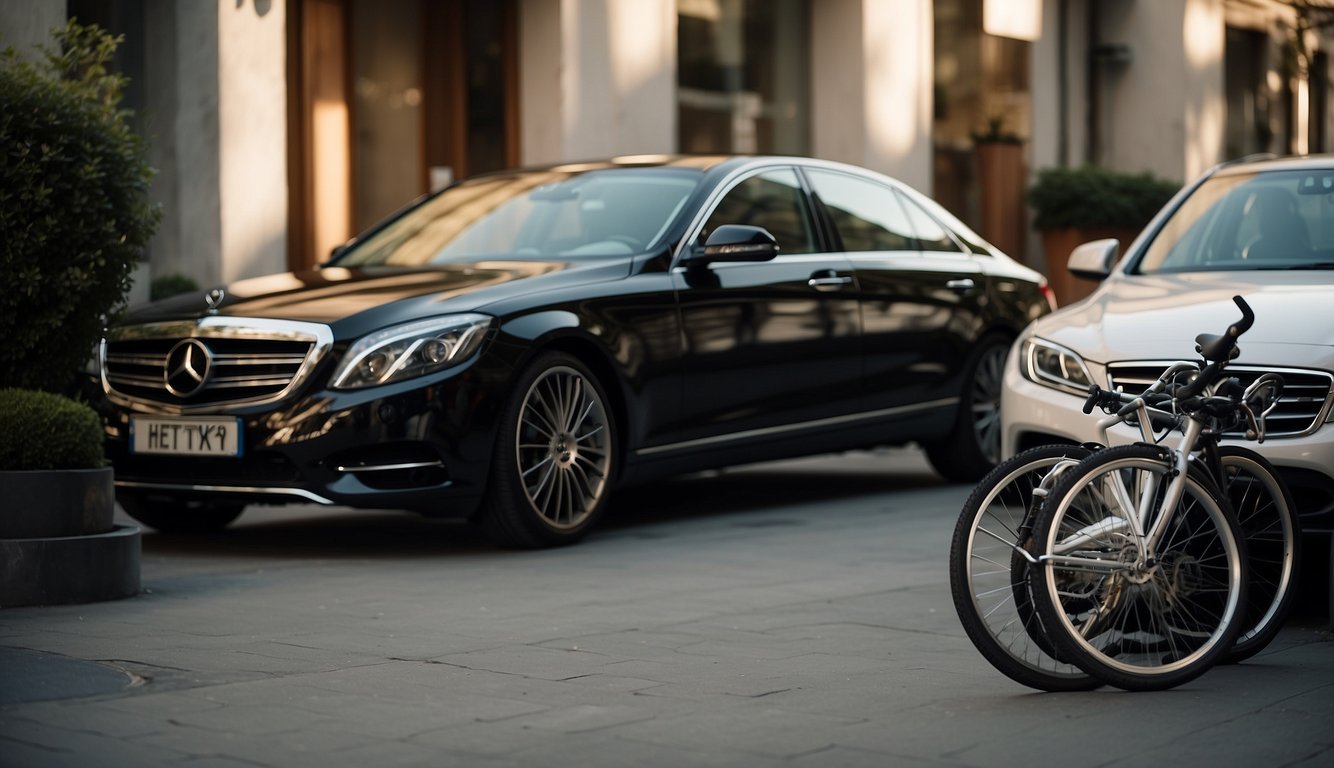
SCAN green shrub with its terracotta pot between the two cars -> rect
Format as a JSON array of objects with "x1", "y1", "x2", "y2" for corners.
[{"x1": 1029, "y1": 165, "x2": 1181, "y2": 305}]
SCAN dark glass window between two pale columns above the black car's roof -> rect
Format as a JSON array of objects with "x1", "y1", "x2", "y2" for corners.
[{"x1": 676, "y1": 0, "x2": 810, "y2": 155}]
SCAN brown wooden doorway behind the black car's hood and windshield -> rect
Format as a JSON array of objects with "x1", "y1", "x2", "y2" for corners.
[{"x1": 288, "y1": 0, "x2": 519, "y2": 269}]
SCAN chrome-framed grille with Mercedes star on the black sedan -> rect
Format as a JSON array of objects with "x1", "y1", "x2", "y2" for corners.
[{"x1": 101, "y1": 317, "x2": 332, "y2": 413}]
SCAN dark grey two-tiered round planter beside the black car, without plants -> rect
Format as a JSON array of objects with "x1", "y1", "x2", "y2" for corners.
[{"x1": 0, "y1": 467, "x2": 140, "y2": 608}]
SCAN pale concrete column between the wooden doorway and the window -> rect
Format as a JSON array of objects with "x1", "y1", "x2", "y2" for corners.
[{"x1": 519, "y1": 0, "x2": 676, "y2": 164}]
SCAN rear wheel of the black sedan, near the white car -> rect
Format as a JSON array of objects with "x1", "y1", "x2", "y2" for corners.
[{"x1": 924, "y1": 333, "x2": 1010, "y2": 483}]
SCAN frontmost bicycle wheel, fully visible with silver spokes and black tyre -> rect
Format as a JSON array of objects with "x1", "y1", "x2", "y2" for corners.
[{"x1": 1030, "y1": 444, "x2": 1247, "y2": 691}]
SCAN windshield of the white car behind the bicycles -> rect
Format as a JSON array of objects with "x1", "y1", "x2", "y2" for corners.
[{"x1": 1133, "y1": 169, "x2": 1334, "y2": 275}]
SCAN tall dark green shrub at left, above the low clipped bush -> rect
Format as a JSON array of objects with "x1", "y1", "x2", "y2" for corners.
[{"x1": 0, "y1": 21, "x2": 160, "y2": 392}]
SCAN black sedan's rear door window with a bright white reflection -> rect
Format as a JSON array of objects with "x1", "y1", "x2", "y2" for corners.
[{"x1": 807, "y1": 171, "x2": 912, "y2": 251}]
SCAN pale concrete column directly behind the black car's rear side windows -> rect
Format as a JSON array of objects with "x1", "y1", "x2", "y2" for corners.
[{"x1": 811, "y1": 0, "x2": 934, "y2": 195}]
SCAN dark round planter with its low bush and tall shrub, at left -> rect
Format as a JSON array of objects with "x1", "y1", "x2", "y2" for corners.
[{"x1": 0, "y1": 21, "x2": 160, "y2": 607}]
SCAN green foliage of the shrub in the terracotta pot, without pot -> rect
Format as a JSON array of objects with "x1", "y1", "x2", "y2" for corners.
[{"x1": 1029, "y1": 165, "x2": 1181, "y2": 229}]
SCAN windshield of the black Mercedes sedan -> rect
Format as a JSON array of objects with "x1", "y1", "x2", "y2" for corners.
[{"x1": 334, "y1": 168, "x2": 702, "y2": 267}]
